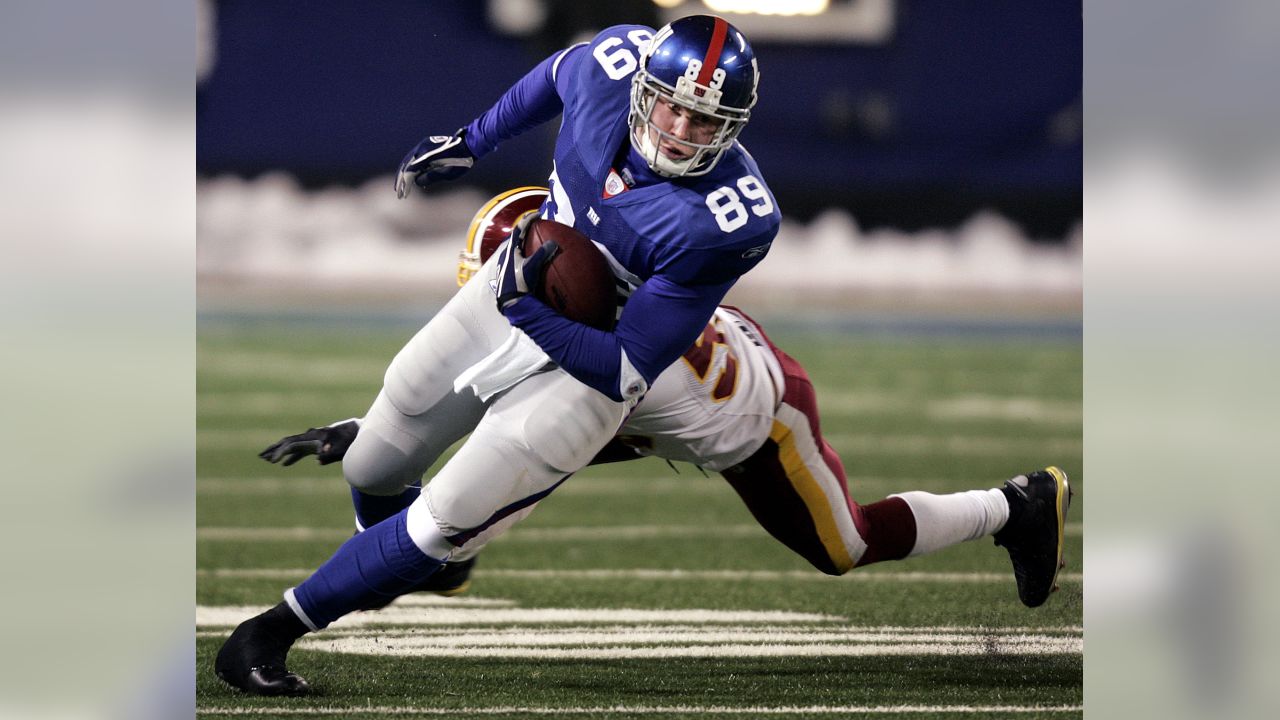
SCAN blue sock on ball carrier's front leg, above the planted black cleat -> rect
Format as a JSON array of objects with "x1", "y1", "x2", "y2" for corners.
[{"x1": 285, "y1": 510, "x2": 444, "y2": 629}]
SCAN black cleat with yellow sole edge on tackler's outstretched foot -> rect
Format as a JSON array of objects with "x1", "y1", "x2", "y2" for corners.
[{"x1": 995, "y1": 466, "x2": 1071, "y2": 607}]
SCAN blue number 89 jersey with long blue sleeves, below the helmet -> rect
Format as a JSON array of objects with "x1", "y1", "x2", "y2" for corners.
[{"x1": 467, "y1": 26, "x2": 781, "y2": 400}]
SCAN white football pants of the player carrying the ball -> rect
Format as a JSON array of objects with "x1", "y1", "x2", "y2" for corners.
[{"x1": 343, "y1": 252, "x2": 626, "y2": 560}]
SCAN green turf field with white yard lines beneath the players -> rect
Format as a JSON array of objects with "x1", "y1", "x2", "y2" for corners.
[{"x1": 196, "y1": 320, "x2": 1084, "y2": 719}]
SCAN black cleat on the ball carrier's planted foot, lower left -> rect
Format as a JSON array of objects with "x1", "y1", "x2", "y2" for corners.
[{"x1": 214, "y1": 602, "x2": 311, "y2": 696}]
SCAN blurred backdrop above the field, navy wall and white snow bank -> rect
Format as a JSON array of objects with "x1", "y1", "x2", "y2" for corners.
[{"x1": 196, "y1": 0, "x2": 1083, "y2": 319}]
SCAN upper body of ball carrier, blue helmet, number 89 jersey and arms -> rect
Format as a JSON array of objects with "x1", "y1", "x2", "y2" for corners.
[{"x1": 397, "y1": 15, "x2": 781, "y2": 401}]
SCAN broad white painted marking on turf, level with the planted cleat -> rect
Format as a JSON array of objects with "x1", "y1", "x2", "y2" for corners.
[{"x1": 196, "y1": 589, "x2": 1084, "y2": 660}]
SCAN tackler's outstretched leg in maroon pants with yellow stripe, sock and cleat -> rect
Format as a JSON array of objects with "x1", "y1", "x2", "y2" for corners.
[{"x1": 724, "y1": 350, "x2": 1071, "y2": 607}]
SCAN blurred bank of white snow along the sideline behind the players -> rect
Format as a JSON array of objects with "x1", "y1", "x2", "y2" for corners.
[{"x1": 196, "y1": 173, "x2": 1083, "y2": 297}]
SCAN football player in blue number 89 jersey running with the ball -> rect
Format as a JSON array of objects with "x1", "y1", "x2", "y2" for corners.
[{"x1": 215, "y1": 15, "x2": 781, "y2": 694}]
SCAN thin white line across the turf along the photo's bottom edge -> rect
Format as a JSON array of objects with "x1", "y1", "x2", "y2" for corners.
[{"x1": 196, "y1": 705, "x2": 1084, "y2": 716}]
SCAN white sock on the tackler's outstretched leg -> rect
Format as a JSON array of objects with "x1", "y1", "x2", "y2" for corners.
[{"x1": 890, "y1": 488, "x2": 1009, "y2": 557}]
